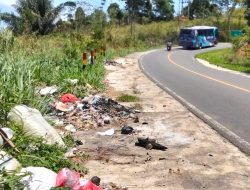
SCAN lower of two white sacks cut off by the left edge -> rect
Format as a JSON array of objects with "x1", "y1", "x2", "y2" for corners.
[{"x1": 0, "y1": 150, "x2": 21, "y2": 172}]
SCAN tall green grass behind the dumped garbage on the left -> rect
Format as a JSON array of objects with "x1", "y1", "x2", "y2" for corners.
[{"x1": 0, "y1": 31, "x2": 104, "y2": 122}]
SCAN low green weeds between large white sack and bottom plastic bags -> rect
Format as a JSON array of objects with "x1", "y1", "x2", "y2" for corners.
[{"x1": 5, "y1": 125, "x2": 87, "y2": 173}]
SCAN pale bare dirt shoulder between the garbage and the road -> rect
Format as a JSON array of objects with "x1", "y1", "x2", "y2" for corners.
[{"x1": 76, "y1": 53, "x2": 250, "y2": 190}]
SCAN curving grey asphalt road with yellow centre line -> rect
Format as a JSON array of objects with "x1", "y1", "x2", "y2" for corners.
[{"x1": 141, "y1": 43, "x2": 250, "y2": 142}]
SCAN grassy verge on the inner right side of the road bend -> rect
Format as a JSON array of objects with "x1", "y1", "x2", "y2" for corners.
[{"x1": 196, "y1": 48, "x2": 250, "y2": 73}]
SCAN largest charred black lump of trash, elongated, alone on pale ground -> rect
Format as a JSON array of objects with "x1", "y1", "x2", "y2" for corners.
[{"x1": 135, "y1": 137, "x2": 168, "y2": 151}]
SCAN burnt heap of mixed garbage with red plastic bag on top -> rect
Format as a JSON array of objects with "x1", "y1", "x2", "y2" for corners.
[{"x1": 46, "y1": 94, "x2": 137, "y2": 132}]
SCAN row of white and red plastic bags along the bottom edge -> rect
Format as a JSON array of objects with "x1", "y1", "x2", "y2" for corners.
[{"x1": 19, "y1": 167, "x2": 117, "y2": 190}]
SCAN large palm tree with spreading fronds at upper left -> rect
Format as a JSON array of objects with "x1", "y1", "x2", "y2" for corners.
[{"x1": 0, "y1": 0, "x2": 76, "y2": 35}]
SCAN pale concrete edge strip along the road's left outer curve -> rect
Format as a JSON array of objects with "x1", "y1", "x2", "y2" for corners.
[{"x1": 138, "y1": 50, "x2": 250, "y2": 155}]
